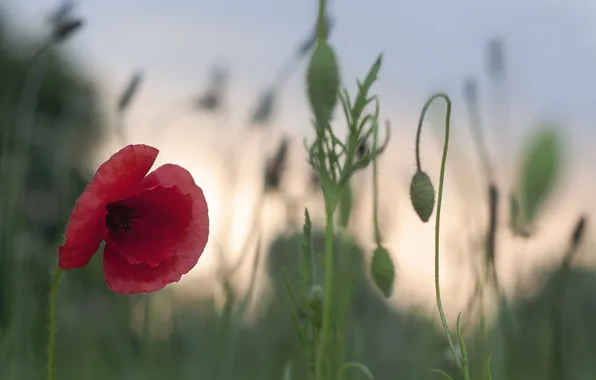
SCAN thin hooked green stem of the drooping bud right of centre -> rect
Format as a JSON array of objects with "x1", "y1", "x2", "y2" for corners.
[{"x1": 416, "y1": 93, "x2": 470, "y2": 380}]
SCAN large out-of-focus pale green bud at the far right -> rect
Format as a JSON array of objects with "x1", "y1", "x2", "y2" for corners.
[{"x1": 520, "y1": 128, "x2": 562, "y2": 223}]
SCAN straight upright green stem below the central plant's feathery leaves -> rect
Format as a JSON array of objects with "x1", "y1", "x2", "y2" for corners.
[{"x1": 315, "y1": 205, "x2": 336, "y2": 380}]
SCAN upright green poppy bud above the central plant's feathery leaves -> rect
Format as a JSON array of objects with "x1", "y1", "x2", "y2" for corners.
[{"x1": 306, "y1": 42, "x2": 339, "y2": 124}]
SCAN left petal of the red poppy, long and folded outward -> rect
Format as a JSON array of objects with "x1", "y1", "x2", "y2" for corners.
[{"x1": 58, "y1": 145, "x2": 159, "y2": 270}]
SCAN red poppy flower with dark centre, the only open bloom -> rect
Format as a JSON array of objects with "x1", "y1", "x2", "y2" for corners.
[{"x1": 58, "y1": 145, "x2": 209, "y2": 294}]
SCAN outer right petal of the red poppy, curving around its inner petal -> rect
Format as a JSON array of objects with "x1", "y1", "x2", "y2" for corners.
[{"x1": 103, "y1": 164, "x2": 209, "y2": 294}]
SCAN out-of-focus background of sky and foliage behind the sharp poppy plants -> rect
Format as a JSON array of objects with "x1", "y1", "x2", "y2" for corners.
[{"x1": 0, "y1": 0, "x2": 596, "y2": 380}]
